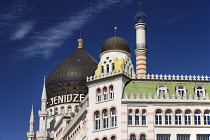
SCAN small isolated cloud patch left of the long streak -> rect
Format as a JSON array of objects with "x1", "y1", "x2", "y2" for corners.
[{"x1": 11, "y1": 21, "x2": 34, "y2": 40}]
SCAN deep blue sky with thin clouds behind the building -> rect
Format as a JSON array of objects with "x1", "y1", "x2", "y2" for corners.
[{"x1": 0, "y1": 0, "x2": 210, "y2": 140}]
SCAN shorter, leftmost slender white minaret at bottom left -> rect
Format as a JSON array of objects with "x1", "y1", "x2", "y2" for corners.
[{"x1": 27, "y1": 104, "x2": 35, "y2": 140}]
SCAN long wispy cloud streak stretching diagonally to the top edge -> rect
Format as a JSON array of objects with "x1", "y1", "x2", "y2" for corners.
[{"x1": 18, "y1": 0, "x2": 128, "y2": 58}]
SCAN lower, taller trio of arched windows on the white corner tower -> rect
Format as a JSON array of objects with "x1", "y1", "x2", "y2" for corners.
[{"x1": 94, "y1": 107, "x2": 117, "y2": 130}]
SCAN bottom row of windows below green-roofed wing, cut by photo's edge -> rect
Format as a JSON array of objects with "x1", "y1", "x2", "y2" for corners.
[{"x1": 129, "y1": 134, "x2": 210, "y2": 140}]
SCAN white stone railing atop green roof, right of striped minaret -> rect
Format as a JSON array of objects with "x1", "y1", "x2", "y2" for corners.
[{"x1": 136, "y1": 74, "x2": 210, "y2": 81}]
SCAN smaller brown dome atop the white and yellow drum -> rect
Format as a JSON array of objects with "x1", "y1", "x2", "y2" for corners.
[{"x1": 101, "y1": 36, "x2": 130, "y2": 53}]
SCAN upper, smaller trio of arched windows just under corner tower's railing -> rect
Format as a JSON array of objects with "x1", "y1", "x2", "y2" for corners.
[{"x1": 96, "y1": 85, "x2": 114, "y2": 102}]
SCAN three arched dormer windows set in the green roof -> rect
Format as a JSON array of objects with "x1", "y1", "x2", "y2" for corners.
[{"x1": 157, "y1": 84, "x2": 205, "y2": 97}]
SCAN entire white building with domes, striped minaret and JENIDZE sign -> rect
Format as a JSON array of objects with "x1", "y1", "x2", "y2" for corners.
[{"x1": 27, "y1": 3, "x2": 210, "y2": 140}]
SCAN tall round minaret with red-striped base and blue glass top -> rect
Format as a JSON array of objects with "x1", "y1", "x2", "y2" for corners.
[{"x1": 135, "y1": 3, "x2": 148, "y2": 75}]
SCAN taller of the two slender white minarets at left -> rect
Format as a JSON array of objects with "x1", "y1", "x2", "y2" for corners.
[{"x1": 37, "y1": 77, "x2": 47, "y2": 140}]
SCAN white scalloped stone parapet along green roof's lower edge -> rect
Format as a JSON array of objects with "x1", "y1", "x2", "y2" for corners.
[{"x1": 123, "y1": 93, "x2": 209, "y2": 102}]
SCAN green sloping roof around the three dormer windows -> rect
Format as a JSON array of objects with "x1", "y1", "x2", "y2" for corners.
[{"x1": 123, "y1": 80, "x2": 210, "y2": 97}]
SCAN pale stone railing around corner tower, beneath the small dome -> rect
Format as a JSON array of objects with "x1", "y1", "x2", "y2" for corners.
[{"x1": 87, "y1": 70, "x2": 134, "y2": 82}]
